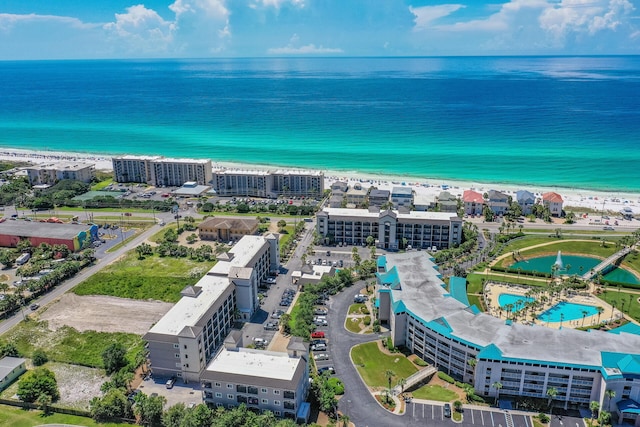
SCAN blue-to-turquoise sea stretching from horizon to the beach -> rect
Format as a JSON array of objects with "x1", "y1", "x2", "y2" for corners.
[{"x1": 0, "y1": 57, "x2": 640, "y2": 192}]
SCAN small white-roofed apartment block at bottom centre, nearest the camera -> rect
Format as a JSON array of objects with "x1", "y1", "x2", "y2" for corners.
[{"x1": 201, "y1": 339, "x2": 310, "y2": 423}]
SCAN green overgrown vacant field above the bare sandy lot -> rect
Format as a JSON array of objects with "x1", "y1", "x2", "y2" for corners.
[{"x1": 73, "y1": 250, "x2": 215, "y2": 302}]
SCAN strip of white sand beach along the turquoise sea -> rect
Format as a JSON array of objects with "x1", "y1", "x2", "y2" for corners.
[{"x1": 0, "y1": 147, "x2": 640, "y2": 214}]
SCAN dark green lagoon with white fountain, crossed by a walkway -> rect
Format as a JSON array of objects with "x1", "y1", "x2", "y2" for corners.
[{"x1": 510, "y1": 255, "x2": 640, "y2": 284}]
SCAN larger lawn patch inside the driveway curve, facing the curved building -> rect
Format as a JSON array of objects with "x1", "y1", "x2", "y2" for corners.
[{"x1": 351, "y1": 341, "x2": 418, "y2": 387}]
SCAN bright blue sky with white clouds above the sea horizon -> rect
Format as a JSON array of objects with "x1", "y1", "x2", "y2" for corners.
[{"x1": 0, "y1": 0, "x2": 640, "y2": 60}]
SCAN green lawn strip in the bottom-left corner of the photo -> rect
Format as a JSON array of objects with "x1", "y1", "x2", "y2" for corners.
[{"x1": 0, "y1": 405, "x2": 131, "y2": 427}]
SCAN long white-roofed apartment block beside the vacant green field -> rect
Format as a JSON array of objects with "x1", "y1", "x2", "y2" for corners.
[{"x1": 143, "y1": 235, "x2": 279, "y2": 381}]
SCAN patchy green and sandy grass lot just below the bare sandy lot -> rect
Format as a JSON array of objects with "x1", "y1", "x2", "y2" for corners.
[{"x1": 3, "y1": 321, "x2": 143, "y2": 368}]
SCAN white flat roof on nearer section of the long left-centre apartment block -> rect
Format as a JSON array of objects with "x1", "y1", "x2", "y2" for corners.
[{"x1": 148, "y1": 275, "x2": 231, "y2": 335}]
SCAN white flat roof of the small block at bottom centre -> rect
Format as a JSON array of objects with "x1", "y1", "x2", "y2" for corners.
[{"x1": 206, "y1": 348, "x2": 301, "y2": 381}]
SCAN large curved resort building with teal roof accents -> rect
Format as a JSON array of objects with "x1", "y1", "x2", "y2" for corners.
[{"x1": 377, "y1": 252, "x2": 640, "y2": 419}]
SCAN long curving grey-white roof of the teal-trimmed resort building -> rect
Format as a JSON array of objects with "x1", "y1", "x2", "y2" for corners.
[{"x1": 383, "y1": 252, "x2": 640, "y2": 367}]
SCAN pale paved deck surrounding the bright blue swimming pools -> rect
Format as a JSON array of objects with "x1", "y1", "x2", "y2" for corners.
[{"x1": 484, "y1": 282, "x2": 623, "y2": 329}]
